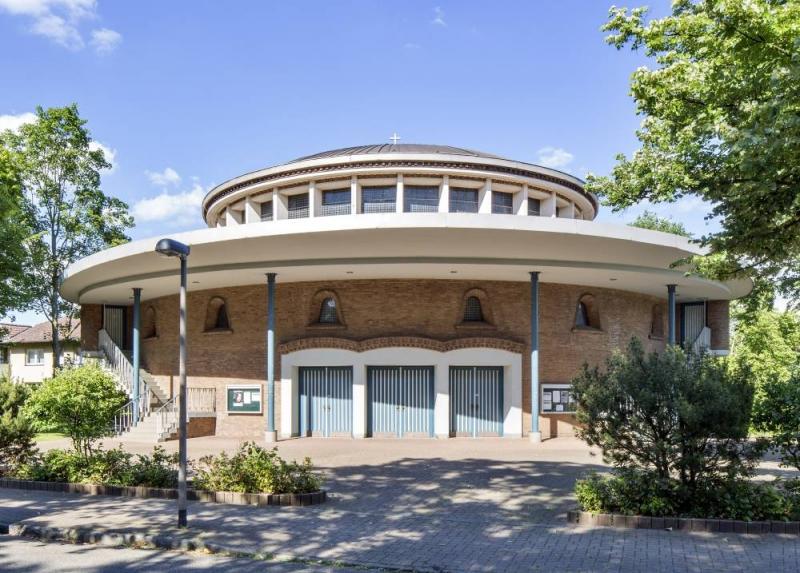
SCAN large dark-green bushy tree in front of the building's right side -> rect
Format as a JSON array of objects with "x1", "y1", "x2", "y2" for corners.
[{"x1": 572, "y1": 338, "x2": 755, "y2": 492}]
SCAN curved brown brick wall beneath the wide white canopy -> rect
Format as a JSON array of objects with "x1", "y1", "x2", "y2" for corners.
[{"x1": 82, "y1": 275, "x2": 728, "y2": 438}]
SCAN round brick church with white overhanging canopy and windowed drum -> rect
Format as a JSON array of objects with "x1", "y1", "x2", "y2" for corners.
[{"x1": 62, "y1": 145, "x2": 750, "y2": 441}]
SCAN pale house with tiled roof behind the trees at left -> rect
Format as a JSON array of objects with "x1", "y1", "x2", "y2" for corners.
[{"x1": 0, "y1": 319, "x2": 81, "y2": 383}]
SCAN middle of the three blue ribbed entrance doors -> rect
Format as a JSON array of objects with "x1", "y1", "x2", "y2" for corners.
[{"x1": 367, "y1": 366, "x2": 434, "y2": 438}]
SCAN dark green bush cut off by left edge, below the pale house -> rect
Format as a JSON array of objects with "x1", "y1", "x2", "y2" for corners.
[{"x1": 0, "y1": 378, "x2": 36, "y2": 473}]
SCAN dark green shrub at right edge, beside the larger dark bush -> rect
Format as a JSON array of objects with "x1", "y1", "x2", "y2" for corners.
[{"x1": 753, "y1": 365, "x2": 800, "y2": 471}]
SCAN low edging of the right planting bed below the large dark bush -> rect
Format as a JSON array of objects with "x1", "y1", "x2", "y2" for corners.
[{"x1": 567, "y1": 510, "x2": 800, "y2": 535}]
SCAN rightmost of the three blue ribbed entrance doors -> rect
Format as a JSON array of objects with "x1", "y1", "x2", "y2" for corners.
[{"x1": 450, "y1": 366, "x2": 503, "y2": 438}]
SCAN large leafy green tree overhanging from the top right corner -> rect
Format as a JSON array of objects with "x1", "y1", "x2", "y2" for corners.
[{"x1": 587, "y1": 0, "x2": 800, "y2": 296}]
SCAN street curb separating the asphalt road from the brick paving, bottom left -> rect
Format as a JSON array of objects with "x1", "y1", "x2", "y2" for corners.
[{"x1": 0, "y1": 523, "x2": 424, "y2": 573}]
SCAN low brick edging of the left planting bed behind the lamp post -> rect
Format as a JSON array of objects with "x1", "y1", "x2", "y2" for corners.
[{"x1": 0, "y1": 478, "x2": 328, "y2": 507}]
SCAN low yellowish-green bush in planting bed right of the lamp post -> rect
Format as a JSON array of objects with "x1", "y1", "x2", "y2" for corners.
[{"x1": 192, "y1": 442, "x2": 322, "y2": 493}]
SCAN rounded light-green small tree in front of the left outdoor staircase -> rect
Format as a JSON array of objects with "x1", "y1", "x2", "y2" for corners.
[{"x1": 25, "y1": 365, "x2": 127, "y2": 457}]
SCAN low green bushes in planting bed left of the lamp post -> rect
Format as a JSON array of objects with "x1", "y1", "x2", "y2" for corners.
[{"x1": 16, "y1": 446, "x2": 178, "y2": 488}]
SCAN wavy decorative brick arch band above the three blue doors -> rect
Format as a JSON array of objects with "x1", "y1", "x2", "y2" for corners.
[{"x1": 278, "y1": 336, "x2": 525, "y2": 355}]
